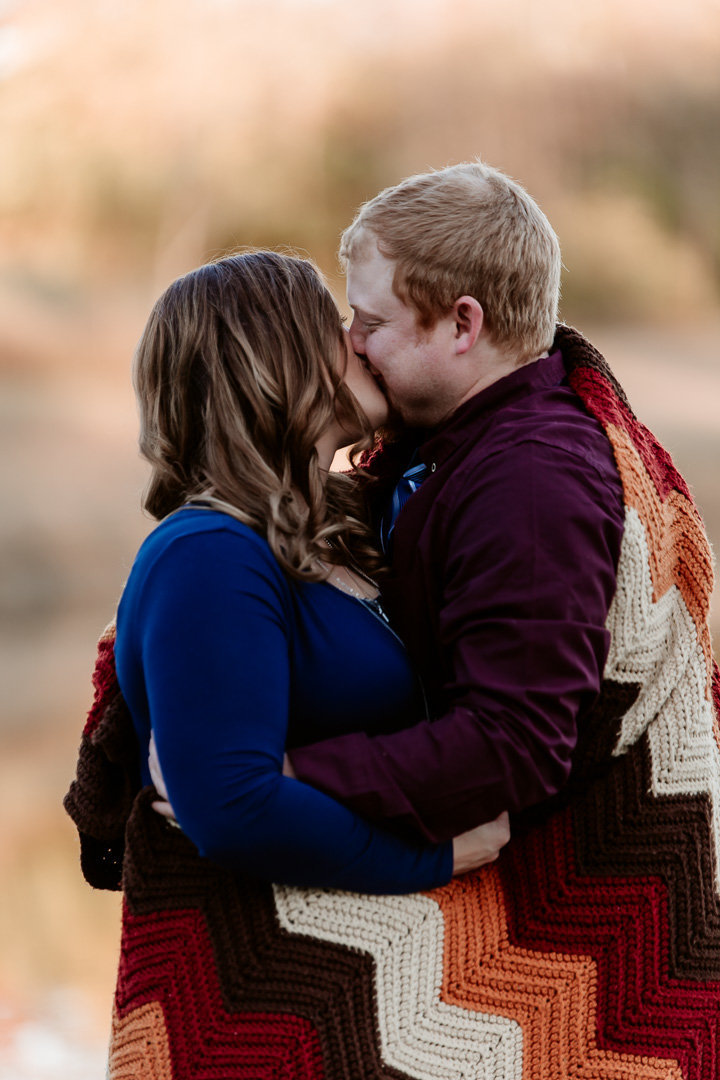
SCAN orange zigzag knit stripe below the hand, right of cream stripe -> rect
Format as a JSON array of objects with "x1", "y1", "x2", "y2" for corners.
[{"x1": 431, "y1": 866, "x2": 682, "y2": 1080}]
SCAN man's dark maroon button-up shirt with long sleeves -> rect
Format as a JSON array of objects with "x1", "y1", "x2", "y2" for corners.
[{"x1": 291, "y1": 352, "x2": 624, "y2": 840}]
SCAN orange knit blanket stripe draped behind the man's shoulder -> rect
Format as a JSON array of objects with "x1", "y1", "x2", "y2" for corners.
[{"x1": 607, "y1": 424, "x2": 714, "y2": 682}]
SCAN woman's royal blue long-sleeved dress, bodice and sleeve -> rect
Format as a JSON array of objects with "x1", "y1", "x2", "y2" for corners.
[{"x1": 116, "y1": 508, "x2": 452, "y2": 893}]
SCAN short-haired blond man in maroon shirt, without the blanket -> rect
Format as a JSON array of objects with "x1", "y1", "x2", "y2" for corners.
[{"x1": 291, "y1": 163, "x2": 624, "y2": 839}]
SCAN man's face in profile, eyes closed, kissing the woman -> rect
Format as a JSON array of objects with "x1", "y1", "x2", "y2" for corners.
[{"x1": 348, "y1": 238, "x2": 457, "y2": 427}]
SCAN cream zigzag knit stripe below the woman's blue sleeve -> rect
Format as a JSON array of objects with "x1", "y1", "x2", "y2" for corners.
[{"x1": 273, "y1": 886, "x2": 522, "y2": 1080}]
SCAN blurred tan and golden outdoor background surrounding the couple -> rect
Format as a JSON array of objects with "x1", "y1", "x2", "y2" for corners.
[{"x1": 0, "y1": 0, "x2": 720, "y2": 1080}]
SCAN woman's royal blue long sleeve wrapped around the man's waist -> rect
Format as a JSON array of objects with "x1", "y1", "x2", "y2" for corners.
[{"x1": 113, "y1": 511, "x2": 451, "y2": 893}]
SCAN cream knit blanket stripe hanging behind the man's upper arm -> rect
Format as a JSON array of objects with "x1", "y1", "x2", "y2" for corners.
[{"x1": 604, "y1": 508, "x2": 720, "y2": 894}]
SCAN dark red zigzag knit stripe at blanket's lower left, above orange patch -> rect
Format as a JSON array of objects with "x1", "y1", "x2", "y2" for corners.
[{"x1": 116, "y1": 910, "x2": 325, "y2": 1080}]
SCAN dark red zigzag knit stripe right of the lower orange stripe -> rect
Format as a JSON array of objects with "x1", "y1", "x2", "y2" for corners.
[{"x1": 501, "y1": 756, "x2": 720, "y2": 1080}]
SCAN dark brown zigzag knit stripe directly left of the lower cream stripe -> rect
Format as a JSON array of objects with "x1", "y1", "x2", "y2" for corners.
[{"x1": 119, "y1": 789, "x2": 416, "y2": 1080}]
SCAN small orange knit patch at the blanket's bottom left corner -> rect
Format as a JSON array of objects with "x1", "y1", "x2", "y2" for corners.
[{"x1": 108, "y1": 1001, "x2": 173, "y2": 1080}]
